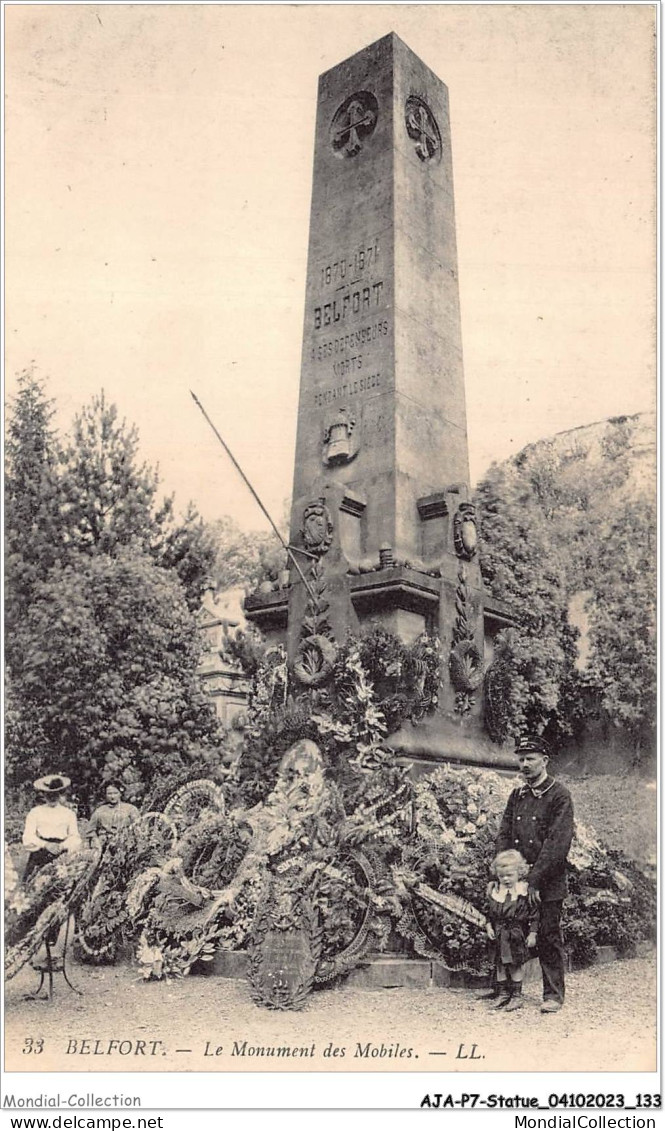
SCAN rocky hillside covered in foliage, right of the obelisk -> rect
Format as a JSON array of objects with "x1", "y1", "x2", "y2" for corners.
[{"x1": 476, "y1": 413, "x2": 657, "y2": 756}]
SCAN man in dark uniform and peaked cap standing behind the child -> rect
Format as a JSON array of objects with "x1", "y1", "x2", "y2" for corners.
[{"x1": 496, "y1": 737, "x2": 575, "y2": 1013}]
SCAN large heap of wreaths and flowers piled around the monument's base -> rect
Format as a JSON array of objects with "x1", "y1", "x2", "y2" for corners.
[{"x1": 14, "y1": 615, "x2": 655, "y2": 1008}]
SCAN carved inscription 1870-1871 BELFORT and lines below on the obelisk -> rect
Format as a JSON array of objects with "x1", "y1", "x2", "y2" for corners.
[{"x1": 310, "y1": 239, "x2": 390, "y2": 406}]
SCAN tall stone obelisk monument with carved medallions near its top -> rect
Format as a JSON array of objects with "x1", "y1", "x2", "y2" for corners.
[{"x1": 247, "y1": 34, "x2": 511, "y2": 763}]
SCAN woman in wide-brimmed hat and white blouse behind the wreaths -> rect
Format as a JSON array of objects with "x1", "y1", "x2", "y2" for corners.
[{"x1": 23, "y1": 774, "x2": 81, "y2": 883}]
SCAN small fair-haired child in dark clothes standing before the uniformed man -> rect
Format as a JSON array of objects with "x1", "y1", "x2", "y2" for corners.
[{"x1": 487, "y1": 848, "x2": 538, "y2": 1013}]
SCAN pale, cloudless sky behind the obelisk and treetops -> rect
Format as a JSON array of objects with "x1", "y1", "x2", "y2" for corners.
[{"x1": 5, "y1": 3, "x2": 656, "y2": 529}]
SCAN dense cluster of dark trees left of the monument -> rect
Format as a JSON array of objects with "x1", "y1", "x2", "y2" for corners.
[{"x1": 7, "y1": 374, "x2": 219, "y2": 798}]
